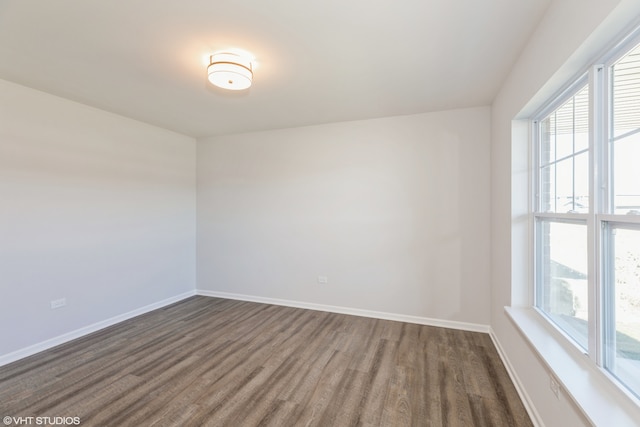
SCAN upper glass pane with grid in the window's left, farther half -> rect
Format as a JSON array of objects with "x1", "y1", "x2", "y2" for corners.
[{"x1": 539, "y1": 86, "x2": 589, "y2": 213}]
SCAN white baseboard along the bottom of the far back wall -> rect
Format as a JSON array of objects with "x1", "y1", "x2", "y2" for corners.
[{"x1": 196, "y1": 289, "x2": 489, "y2": 333}]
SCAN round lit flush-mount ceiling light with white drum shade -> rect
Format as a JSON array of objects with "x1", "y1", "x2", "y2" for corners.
[{"x1": 207, "y1": 52, "x2": 253, "y2": 90}]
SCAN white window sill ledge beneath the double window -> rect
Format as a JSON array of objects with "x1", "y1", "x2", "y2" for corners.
[{"x1": 505, "y1": 307, "x2": 640, "y2": 426}]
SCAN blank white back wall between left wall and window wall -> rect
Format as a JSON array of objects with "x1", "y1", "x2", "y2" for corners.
[{"x1": 197, "y1": 107, "x2": 490, "y2": 325}]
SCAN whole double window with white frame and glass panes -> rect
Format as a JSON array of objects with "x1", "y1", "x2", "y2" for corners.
[{"x1": 533, "y1": 32, "x2": 640, "y2": 397}]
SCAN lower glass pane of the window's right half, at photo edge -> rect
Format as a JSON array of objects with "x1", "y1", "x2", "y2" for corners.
[{"x1": 605, "y1": 227, "x2": 640, "y2": 396}]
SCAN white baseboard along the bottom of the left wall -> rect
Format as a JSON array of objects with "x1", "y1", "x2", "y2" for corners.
[{"x1": 0, "y1": 291, "x2": 196, "y2": 366}]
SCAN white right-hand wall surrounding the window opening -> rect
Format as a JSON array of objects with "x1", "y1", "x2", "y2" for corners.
[{"x1": 491, "y1": 0, "x2": 640, "y2": 427}]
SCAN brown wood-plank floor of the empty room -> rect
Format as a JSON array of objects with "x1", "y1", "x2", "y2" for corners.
[{"x1": 0, "y1": 296, "x2": 532, "y2": 427}]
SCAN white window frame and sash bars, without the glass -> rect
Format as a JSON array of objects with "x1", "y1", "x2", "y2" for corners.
[{"x1": 530, "y1": 29, "x2": 640, "y2": 404}]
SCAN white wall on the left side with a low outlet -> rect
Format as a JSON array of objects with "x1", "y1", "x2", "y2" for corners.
[{"x1": 0, "y1": 81, "x2": 195, "y2": 356}]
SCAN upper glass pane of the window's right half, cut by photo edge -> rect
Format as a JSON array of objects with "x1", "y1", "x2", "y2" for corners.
[{"x1": 610, "y1": 41, "x2": 640, "y2": 214}]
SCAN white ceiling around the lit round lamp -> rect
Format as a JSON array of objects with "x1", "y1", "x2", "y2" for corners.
[{"x1": 0, "y1": 0, "x2": 550, "y2": 137}]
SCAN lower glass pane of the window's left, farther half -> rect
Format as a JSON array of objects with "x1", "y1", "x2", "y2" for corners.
[{"x1": 536, "y1": 220, "x2": 588, "y2": 349}]
